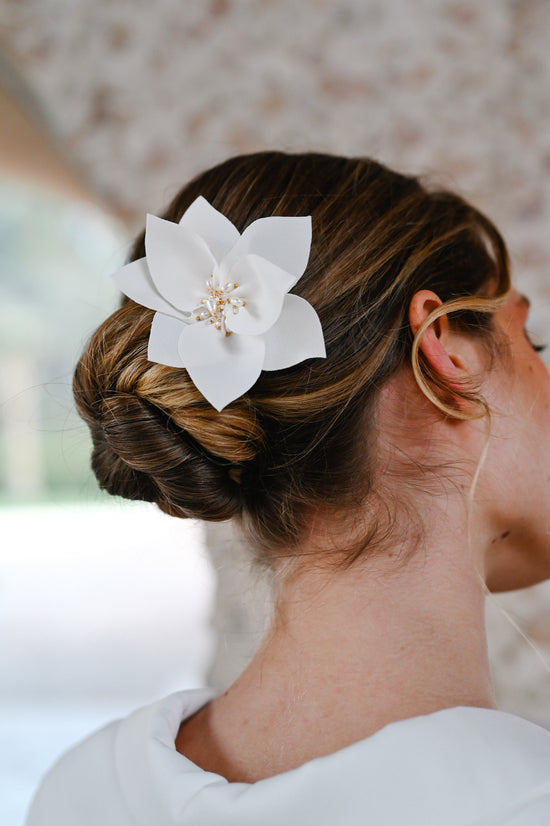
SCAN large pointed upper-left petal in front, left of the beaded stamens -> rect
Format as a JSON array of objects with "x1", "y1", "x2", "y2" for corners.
[{"x1": 145, "y1": 215, "x2": 216, "y2": 311}]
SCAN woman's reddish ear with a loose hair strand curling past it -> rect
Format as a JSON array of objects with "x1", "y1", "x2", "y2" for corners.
[{"x1": 409, "y1": 290, "x2": 482, "y2": 391}]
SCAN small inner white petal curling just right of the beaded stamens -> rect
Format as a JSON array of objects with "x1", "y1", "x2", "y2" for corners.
[{"x1": 226, "y1": 255, "x2": 293, "y2": 336}]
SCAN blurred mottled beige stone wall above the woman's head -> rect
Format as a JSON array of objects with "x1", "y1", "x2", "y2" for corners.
[{"x1": 4, "y1": 0, "x2": 550, "y2": 724}]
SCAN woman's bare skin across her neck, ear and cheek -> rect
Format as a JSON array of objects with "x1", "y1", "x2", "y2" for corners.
[{"x1": 176, "y1": 290, "x2": 550, "y2": 782}]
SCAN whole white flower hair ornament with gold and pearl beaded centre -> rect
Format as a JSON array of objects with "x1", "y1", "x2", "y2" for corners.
[{"x1": 113, "y1": 196, "x2": 326, "y2": 411}]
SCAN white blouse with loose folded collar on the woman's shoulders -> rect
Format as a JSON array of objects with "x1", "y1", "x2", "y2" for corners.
[{"x1": 26, "y1": 690, "x2": 550, "y2": 826}]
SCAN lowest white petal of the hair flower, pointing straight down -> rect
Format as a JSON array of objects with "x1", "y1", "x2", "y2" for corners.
[{"x1": 179, "y1": 322, "x2": 265, "y2": 410}]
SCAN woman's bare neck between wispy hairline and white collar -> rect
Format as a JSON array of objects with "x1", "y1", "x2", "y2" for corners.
[{"x1": 177, "y1": 520, "x2": 494, "y2": 782}]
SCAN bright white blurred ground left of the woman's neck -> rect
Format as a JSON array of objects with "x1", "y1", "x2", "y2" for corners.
[{"x1": 0, "y1": 502, "x2": 214, "y2": 826}]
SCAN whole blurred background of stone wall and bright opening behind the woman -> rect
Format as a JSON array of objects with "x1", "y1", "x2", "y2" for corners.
[{"x1": 0, "y1": 0, "x2": 550, "y2": 826}]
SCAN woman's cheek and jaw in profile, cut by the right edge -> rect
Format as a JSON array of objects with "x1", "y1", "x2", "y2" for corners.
[{"x1": 479, "y1": 292, "x2": 550, "y2": 591}]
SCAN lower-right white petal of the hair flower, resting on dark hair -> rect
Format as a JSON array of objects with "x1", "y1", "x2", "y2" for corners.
[{"x1": 263, "y1": 295, "x2": 326, "y2": 370}]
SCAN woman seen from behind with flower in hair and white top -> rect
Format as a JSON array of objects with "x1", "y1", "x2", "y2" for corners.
[{"x1": 28, "y1": 153, "x2": 550, "y2": 826}]
